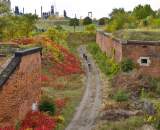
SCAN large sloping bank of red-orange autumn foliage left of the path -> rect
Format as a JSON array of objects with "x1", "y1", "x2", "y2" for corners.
[{"x1": 13, "y1": 36, "x2": 82, "y2": 76}]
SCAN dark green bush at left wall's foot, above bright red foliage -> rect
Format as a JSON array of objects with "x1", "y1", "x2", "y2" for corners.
[{"x1": 38, "y1": 97, "x2": 55, "y2": 116}]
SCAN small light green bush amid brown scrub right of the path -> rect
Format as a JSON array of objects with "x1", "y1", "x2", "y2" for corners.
[{"x1": 113, "y1": 90, "x2": 129, "y2": 102}]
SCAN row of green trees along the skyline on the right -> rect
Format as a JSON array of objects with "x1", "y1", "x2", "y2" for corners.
[{"x1": 70, "y1": 4, "x2": 160, "y2": 32}]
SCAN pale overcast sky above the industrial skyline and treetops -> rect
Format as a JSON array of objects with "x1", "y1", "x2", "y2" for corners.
[{"x1": 11, "y1": 0, "x2": 160, "y2": 18}]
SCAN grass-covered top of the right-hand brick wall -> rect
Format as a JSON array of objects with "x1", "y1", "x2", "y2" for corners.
[{"x1": 113, "y1": 29, "x2": 160, "y2": 41}]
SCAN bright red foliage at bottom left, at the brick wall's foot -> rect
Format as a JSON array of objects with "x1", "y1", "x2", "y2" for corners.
[{"x1": 20, "y1": 112, "x2": 56, "y2": 130}]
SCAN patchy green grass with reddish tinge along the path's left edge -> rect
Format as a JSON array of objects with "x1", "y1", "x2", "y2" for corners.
[{"x1": 42, "y1": 74, "x2": 84, "y2": 130}]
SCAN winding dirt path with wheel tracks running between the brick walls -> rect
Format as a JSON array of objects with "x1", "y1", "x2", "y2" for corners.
[{"x1": 66, "y1": 46, "x2": 101, "y2": 130}]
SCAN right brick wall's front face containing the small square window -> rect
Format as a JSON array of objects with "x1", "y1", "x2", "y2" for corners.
[{"x1": 122, "y1": 43, "x2": 160, "y2": 77}]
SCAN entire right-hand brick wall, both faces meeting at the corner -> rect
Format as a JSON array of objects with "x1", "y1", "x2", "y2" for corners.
[{"x1": 96, "y1": 32, "x2": 160, "y2": 77}]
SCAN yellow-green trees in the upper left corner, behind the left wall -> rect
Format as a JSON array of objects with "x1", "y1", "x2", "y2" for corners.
[{"x1": 0, "y1": 3, "x2": 38, "y2": 40}]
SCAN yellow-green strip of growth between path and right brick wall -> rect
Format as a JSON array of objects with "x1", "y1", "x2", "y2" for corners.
[{"x1": 87, "y1": 42, "x2": 120, "y2": 77}]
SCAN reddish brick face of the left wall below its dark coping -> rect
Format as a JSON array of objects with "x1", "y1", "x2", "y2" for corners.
[{"x1": 0, "y1": 52, "x2": 41, "y2": 126}]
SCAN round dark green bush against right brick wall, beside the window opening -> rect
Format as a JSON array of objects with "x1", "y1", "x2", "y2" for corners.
[{"x1": 121, "y1": 59, "x2": 134, "y2": 72}]
